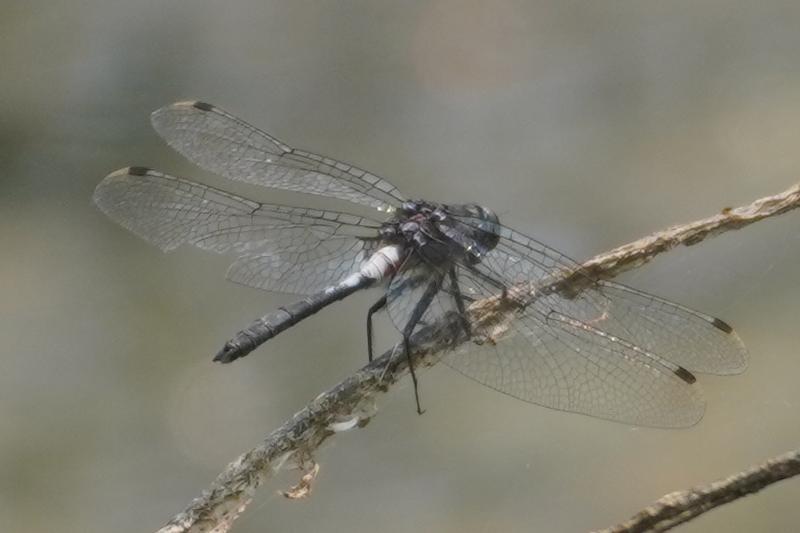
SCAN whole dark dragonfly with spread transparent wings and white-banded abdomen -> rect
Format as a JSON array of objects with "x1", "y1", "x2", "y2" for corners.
[{"x1": 93, "y1": 101, "x2": 747, "y2": 427}]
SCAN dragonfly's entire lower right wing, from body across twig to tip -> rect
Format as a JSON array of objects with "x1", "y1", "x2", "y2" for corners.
[{"x1": 387, "y1": 255, "x2": 704, "y2": 427}]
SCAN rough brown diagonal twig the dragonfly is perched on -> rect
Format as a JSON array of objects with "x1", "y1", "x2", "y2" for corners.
[{"x1": 158, "y1": 184, "x2": 800, "y2": 533}]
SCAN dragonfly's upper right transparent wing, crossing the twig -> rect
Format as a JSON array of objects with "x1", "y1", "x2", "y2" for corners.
[{"x1": 446, "y1": 218, "x2": 747, "y2": 374}]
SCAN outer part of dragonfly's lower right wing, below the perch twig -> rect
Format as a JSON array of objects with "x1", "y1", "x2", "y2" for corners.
[{"x1": 444, "y1": 298, "x2": 705, "y2": 427}]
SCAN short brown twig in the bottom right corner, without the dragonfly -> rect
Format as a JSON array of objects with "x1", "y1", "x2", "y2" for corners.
[{"x1": 595, "y1": 450, "x2": 800, "y2": 533}]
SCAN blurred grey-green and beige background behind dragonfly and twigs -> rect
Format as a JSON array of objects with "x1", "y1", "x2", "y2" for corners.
[{"x1": 0, "y1": 0, "x2": 800, "y2": 533}]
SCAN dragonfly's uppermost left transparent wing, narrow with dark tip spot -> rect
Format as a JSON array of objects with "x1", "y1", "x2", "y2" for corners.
[{"x1": 151, "y1": 102, "x2": 403, "y2": 211}]
